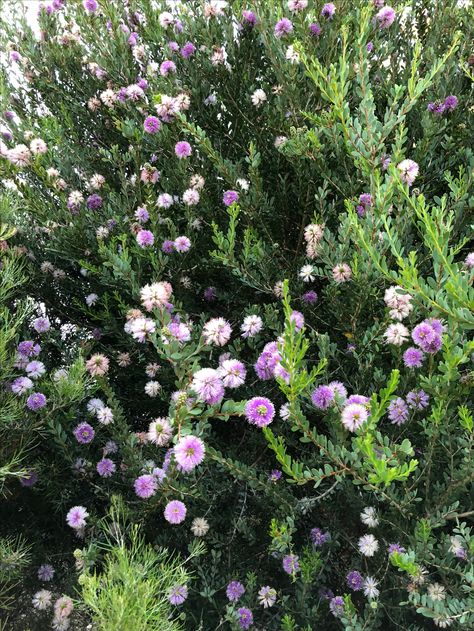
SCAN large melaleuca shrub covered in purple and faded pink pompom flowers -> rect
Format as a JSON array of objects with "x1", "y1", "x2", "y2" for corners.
[{"x1": 1, "y1": 0, "x2": 474, "y2": 630}]
